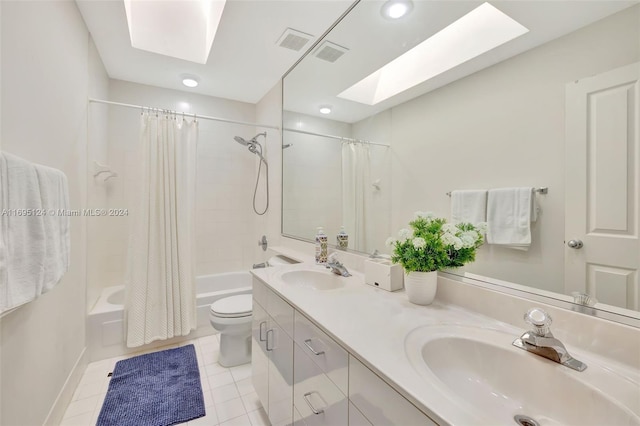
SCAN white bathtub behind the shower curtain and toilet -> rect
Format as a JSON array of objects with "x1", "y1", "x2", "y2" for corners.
[{"x1": 87, "y1": 271, "x2": 251, "y2": 361}]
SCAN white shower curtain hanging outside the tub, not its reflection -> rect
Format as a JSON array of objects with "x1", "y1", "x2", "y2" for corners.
[{"x1": 125, "y1": 112, "x2": 198, "y2": 347}]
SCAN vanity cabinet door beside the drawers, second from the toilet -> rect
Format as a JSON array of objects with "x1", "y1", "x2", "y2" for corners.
[{"x1": 266, "y1": 318, "x2": 293, "y2": 426}]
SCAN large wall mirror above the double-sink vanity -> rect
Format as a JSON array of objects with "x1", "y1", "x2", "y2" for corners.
[{"x1": 282, "y1": 0, "x2": 640, "y2": 318}]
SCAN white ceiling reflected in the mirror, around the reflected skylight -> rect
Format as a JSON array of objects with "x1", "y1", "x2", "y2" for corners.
[{"x1": 284, "y1": 0, "x2": 639, "y2": 123}]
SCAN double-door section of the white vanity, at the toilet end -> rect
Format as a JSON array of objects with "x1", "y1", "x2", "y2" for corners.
[{"x1": 251, "y1": 280, "x2": 293, "y2": 426}]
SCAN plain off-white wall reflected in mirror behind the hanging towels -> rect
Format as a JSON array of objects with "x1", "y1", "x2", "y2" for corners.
[{"x1": 392, "y1": 6, "x2": 640, "y2": 292}]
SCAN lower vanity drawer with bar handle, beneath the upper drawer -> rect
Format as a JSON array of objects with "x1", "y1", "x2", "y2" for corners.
[{"x1": 293, "y1": 344, "x2": 349, "y2": 426}]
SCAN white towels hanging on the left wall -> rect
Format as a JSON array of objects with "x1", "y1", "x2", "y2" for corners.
[{"x1": 0, "y1": 153, "x2": 70, "y2": 314}]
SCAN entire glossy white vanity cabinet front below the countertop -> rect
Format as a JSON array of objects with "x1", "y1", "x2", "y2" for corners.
[{"x1": 252, "y1": 278, "x2": 436, "y2": 426}]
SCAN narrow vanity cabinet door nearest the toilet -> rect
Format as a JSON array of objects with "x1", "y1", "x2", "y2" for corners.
[{"x1": 251, "y1": 299, "x2": 269, "y2": 414}]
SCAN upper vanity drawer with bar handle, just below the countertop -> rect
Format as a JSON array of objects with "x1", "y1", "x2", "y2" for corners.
[{"x1": 294, "y1": 311, "x2": 349, "y2": 395}]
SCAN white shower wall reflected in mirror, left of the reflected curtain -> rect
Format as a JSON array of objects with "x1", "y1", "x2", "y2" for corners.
[{"x1": 282, "y1": 111, "x2": 351, "y2": 244}]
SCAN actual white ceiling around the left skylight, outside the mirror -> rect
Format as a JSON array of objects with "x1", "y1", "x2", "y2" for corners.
[{"x1": 76, "y1": 0, "x2": 352, "y2": 103}]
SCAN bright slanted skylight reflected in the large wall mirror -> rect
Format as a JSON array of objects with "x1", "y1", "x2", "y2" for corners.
[{"x1": 338, "y1": 3, "x2": 529, "y2": 105}]
